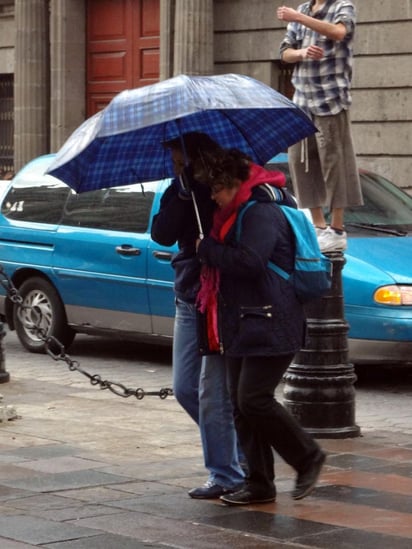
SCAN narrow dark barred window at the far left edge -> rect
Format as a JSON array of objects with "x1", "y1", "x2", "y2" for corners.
[{"x1": 0, "y1": 74, "x2": 14, "y2": 179}]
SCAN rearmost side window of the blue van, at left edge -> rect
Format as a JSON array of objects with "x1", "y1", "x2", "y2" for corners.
[{"x1": 1, "y1": 176, "x2": 70, "y2": 224}]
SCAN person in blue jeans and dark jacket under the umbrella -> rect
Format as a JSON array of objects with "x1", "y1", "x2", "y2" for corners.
[{"x1": 151, "y1": 132, "x2": 244, "y2": 499}]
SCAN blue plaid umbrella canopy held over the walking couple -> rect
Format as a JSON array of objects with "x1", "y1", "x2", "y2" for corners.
[{"x1": 48, "y1": 74, "x2": 316, "y2": 192}]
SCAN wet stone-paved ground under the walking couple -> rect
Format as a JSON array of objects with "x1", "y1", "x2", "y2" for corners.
[{"x1": 0, "y1": 334, "x2": 412, "y2": 549}]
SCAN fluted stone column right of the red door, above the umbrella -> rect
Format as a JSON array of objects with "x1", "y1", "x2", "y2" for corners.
[{"x1": 173, "y1": 0, "x2": 214, "y2": 76}]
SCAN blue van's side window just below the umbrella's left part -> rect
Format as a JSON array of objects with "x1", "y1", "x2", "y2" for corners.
[{"x1": 62, "y1": 183, "x2": 155, "y2": 233}]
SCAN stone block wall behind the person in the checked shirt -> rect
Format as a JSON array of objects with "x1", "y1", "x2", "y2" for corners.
[{"x1": 214, "y1": 0, "x2": 412, "y2": 188}]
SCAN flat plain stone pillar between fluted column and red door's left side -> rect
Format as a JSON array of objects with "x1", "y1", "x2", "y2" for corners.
[{"x1": 50, "y1": 0, "x2": 86, "y2": 151}]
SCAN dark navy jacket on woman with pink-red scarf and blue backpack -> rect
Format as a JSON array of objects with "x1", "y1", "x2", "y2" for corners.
[{"x1": 198, "y1": 187, "x2": 305, "y2": 357}]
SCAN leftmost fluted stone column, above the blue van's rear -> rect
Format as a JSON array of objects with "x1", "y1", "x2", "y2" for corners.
[{"x1": 14, "y1": 0, "x2": 49, "y2": 170}]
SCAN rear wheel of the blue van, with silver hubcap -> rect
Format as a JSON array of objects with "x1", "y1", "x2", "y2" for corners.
[{"x1": 13, "y1": 278, "x2": 75, "y2": 353}]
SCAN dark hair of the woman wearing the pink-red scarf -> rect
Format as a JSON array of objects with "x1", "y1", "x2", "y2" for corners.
[{"x1": 194, "y1": 149, "x2": 251, "y2": 189}]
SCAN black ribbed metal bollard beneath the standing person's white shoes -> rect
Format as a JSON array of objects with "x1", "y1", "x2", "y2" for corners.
[{"x1": 283, "y1": 252, "x2": 360, "y2": 438}]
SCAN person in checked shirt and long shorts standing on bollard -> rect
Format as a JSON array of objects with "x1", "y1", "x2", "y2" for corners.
[{"x1": 277, "y1": 0, "x2": 363, "y2": 252}]
